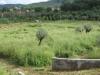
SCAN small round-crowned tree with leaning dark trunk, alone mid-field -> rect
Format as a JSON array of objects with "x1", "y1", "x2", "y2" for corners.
[{"x1": 36, "y1": 28, "x2": 47, "y2": 45}]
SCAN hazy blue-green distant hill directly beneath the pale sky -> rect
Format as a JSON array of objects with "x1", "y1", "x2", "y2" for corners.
[{"x1": 0, "y1": 0, "x2": 73, "y2": 8}]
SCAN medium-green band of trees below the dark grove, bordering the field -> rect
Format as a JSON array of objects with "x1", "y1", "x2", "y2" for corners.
[{"x1": 0, "y1": 7, "x2": 100, "y2": 22}]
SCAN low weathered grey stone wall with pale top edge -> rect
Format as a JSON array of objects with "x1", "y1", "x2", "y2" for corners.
[{"x1": 52, "y1": 58, "x2": 100, "y2": 71}]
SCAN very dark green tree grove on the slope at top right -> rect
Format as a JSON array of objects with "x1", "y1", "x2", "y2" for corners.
[{"x1": 61, "y1": 0, "x2": 100, "y2": 11}]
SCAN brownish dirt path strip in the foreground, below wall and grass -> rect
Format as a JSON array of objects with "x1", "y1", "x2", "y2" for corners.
[{"x1": 0, "y1": 59, "x2": 100, "y2": 75}]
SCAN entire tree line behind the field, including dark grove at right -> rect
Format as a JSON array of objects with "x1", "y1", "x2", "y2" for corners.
[{"x1": 0, "y1": 0, "x2": 100, "y2": 21}]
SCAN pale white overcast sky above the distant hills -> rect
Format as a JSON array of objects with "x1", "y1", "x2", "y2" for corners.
[{"x1": 0, "y1": 0, "x2": 48, "y2": 4}]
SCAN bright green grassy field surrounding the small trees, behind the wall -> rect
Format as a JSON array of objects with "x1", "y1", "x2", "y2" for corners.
[{"x1": 0, "y1": 20, "x2": 100, "y2": 67}]
